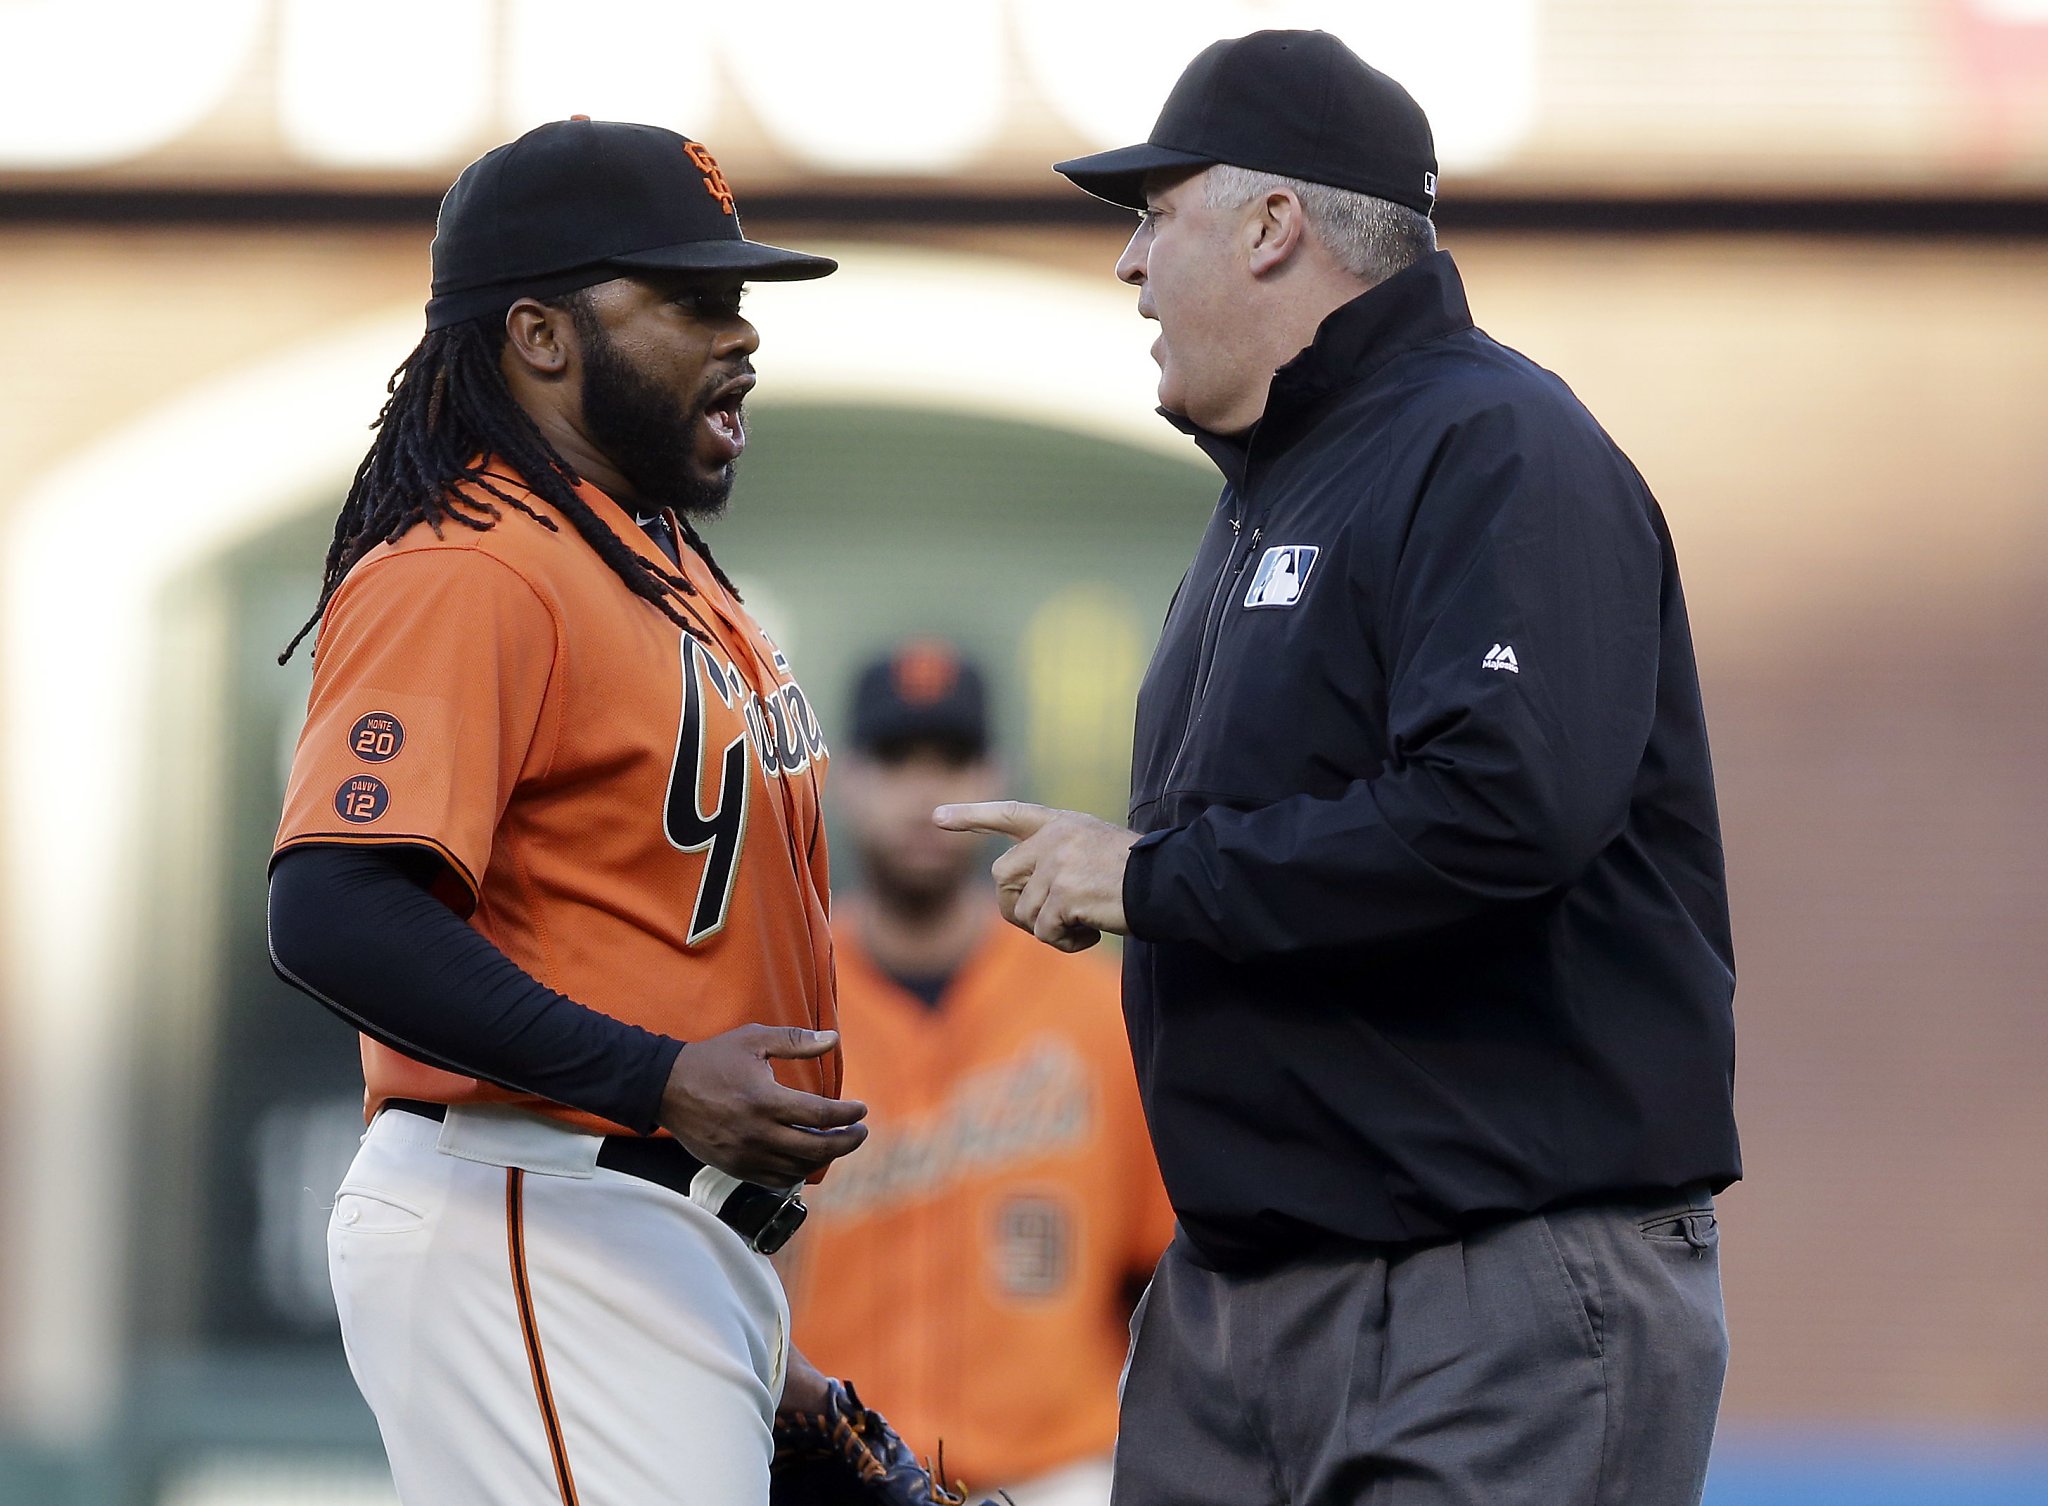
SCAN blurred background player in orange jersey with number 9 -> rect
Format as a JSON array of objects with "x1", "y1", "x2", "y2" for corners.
[{"x1": 784, "y1": 641, "x2": 1174, "y2": 1506}]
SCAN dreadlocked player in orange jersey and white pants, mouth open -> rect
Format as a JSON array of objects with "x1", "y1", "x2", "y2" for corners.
[{"x1": 270, "y1": 119, "x2": 974, "y2": 1506}]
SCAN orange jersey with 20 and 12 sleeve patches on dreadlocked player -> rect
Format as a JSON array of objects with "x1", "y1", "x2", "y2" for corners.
[{"x1": 276, "y1": 477, "x2": 840, "y2": 1131}]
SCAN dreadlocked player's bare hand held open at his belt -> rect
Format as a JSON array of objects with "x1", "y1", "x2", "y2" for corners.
[{"x1": 662, "y1": 1024, "x2": 868, "y2": 1186}]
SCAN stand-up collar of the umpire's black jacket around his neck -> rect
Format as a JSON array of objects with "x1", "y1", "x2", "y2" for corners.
[{"x1": 1159, "y1": 252, "x2": 1473, "y2": 490}]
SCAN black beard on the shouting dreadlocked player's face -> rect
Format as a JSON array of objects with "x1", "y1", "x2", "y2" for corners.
[{"x1": 573, "y1": 309, "x2": 745, "y2": 518}]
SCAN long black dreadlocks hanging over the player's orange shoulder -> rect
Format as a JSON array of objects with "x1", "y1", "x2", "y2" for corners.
[{"x1": 276, "y1": 295, "x2": 739, "y2": 664}]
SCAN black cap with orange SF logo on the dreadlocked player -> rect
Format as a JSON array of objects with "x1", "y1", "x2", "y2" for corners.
[{"x1": 426, "y1": 117, "x2": 840, "y2": 330}]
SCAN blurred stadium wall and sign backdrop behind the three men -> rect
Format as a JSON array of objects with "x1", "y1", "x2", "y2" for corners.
[{"x1": 0, "y1": 0, "x2": 2048, "y2": 1506}]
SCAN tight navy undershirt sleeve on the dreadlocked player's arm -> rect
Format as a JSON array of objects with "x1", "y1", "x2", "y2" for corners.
[{"x1": 270, "y1": 846, "x2": 682, "y2": 1135}]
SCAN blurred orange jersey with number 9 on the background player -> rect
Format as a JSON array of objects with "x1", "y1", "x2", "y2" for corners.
[{"x1": 784, "y1": 912, "x2": 1174, "y2": 1488}]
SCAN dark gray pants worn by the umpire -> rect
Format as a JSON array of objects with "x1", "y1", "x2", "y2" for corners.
[{"x1": 1110, "y1": 1193, "x2": 1729, "y2": 1506}]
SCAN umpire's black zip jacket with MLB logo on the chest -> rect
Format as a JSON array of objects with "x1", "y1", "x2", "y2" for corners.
[{"x1": 1124, "y1": 252, "x2": 1741, "y2": 1266}]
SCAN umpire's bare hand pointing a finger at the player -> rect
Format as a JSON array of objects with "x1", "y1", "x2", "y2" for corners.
[{"x1": 932, "y1": 799, "x2": 1139, "y2": 951}]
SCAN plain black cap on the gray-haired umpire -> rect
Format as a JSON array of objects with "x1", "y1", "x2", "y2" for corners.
[{"x1": 1053, "y1": 31, "x2": 1436, "y2": 215}]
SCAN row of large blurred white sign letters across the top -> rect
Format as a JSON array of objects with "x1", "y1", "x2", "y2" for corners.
[{"x1": 0, "y1": 0, "x2": 1536, "y2": 176}]
